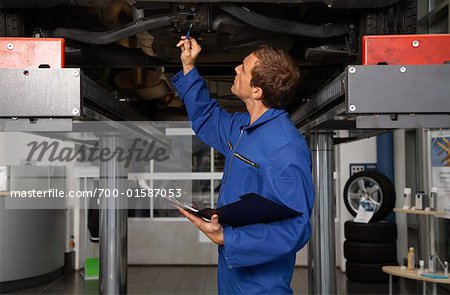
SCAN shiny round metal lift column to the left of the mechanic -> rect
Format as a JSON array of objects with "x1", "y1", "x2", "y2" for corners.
[{"x1": 99, "y1": 134, "x2": 128, "y2": 295}]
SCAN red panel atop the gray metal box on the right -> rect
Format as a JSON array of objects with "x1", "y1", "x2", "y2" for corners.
[{"x1": 362, "y1": 34, "x2": 450, "y2": 65}]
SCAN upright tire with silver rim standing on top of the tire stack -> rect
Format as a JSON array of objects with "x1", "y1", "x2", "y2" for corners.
[{"x1": 344, "y1": 171, "x2": 395, "y2": 222}]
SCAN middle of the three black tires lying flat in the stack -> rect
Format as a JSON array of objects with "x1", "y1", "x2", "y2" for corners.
[{"x1": 344, "y1": 241, "x2": 397, "y2": 263}]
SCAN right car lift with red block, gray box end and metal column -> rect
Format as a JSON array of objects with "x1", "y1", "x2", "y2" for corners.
[{"x1": 291, "y1": 34, "x2": 450, "y2": 294}]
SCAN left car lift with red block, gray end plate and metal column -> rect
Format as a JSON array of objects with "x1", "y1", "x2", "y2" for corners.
[{"x1": 0, "y1": 38, "x2": 168, "y2": 294}]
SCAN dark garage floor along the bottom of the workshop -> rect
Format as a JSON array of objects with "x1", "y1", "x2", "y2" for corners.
[{"x1": 4, "y1": 266, "x2": 449, "y2": 295}]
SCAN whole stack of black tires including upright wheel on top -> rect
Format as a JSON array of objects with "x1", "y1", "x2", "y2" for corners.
[{"x1": 344, "y1": 171, "x2": 398, "y2": 283}]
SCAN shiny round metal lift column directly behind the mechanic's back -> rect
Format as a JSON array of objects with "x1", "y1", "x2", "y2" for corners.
[{"x1": 308, "y1": 131, "x2": 336, "y2": 294}]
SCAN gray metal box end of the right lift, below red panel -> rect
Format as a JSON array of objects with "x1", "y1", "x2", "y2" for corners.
[{"x1": 346, "y1": 64, "x2": 450, "y2": 114}]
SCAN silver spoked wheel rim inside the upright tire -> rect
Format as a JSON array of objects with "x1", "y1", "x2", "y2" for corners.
[{"x1": 346, "y1": 176, "x2": 383, "y2": 213}]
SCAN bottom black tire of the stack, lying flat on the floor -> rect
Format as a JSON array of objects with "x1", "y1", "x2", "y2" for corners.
[{"x1": 346, "y1": 261, "x2": 398, "y2": 283}]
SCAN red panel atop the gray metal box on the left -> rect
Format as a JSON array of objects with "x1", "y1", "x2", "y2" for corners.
[{"x1": 0, "y1": 38, "x2": 65, "y2": 69}]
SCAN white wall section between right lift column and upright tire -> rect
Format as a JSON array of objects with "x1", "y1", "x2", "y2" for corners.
[{"x1": 335, "y1": 131, "x2": 377, "y2": 271}]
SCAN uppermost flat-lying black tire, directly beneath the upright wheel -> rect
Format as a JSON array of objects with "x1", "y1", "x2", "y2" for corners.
[{"x1": 344, "y1": 220, "x2": 397, "y2": 243}]
